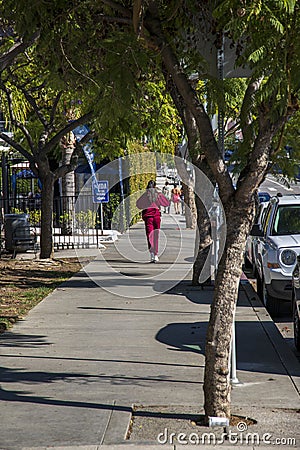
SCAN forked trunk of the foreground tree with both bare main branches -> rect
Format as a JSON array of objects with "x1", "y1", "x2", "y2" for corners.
[{"x1": 144, "y1": 1, "x2": 286, "y2": 417}]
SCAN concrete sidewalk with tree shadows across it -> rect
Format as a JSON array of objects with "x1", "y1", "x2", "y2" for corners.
[{"x1": 0, "y1": 215, "x2": 300, "y2": 450}]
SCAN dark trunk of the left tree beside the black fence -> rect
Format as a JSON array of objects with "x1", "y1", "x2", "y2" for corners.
[{"x1": 40, "y1": 171, "x2": 54, "y2": 259}]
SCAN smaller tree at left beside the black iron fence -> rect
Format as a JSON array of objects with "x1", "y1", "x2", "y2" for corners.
[{"x1": 0, "y1": 51, "x2": 91, "y2": 258}]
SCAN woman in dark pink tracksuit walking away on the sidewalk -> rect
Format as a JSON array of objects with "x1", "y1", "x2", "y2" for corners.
[{"x1": 136, "y1": 180, "x2": 170, "y2": 263}]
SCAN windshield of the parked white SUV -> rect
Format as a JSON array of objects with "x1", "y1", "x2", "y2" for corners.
[{"x1": 273, "y1": 205, "x2": 300, "y2": 235}]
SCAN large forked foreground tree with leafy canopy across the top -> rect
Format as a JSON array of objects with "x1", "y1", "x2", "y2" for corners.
[{"x1": 2, "y1": 0, "x2": 300, "y2": 417}]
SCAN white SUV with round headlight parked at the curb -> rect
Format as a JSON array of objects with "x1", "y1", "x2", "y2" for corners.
[{"x1": 251, "y1": 195, "x2": 300, "y2": 315}]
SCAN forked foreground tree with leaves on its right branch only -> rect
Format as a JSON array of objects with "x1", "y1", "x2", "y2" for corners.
[{"x1": 144, "y1": 2, "x2": 299, "y2": 417}]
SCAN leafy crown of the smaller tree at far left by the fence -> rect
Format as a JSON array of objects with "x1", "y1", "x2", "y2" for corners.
[{"x1": 0, "y1": 40, "x2": 90, "y2": 157}]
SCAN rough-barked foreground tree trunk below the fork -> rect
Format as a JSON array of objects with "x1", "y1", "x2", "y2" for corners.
[{"x1": 203, "y1": 199, "x2": 254, "y2": 418}]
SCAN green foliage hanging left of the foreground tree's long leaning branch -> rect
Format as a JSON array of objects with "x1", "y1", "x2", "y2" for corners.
[{"x1": 0, "y1": 0, "x2": 179, "y2": 159}]
